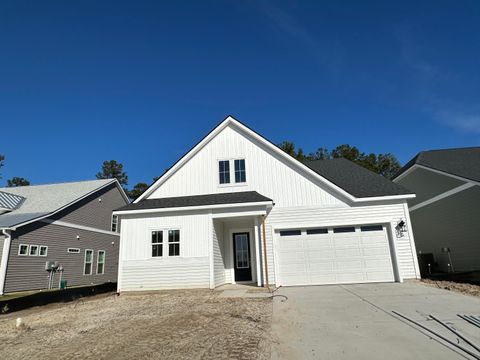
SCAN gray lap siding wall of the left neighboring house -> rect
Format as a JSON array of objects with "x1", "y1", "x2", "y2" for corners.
[{"x1": 5, "y1": 222, "x2": 120, "y2": 293}]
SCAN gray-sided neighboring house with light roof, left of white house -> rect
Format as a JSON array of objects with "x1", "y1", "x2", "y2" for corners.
[{"x1": 0, "y1": 179, "x2": 129, "y2": 295}]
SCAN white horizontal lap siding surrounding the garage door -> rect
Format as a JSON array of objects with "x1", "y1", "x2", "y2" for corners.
[{"x1": 266, "y1": 203, "x2": 417, "y2": 283}]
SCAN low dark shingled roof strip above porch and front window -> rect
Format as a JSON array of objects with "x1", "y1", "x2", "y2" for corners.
[{"x1": 115, "y1": 191, "x2": 273, "y2": 212}]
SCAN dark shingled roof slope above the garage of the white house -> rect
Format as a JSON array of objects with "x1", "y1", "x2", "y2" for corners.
[{"x1": 305, "y1": 158, "x2": 412, "y2": 198}]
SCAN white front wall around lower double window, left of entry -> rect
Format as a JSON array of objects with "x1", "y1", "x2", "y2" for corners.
[{"x1": 119, "y1": 212, "x2": 211, "y2": 291}]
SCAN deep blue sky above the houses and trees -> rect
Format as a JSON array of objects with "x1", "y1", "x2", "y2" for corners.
[{"x1": 0, "y1": 0, "x2": 480, "y2": 186}]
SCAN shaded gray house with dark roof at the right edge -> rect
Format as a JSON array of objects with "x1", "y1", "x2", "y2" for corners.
[{"x1": 393, "y1": 147, "x2": 480, "y2": 272}]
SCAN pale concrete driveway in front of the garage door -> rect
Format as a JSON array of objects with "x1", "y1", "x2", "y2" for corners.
[{"x1": 272, "y1": 282, "x2": 480, "y2": 360}]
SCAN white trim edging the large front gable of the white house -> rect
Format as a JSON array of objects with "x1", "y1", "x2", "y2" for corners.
[{"x1": 137, "y1": 116, "x2": 415, "y2": 203}]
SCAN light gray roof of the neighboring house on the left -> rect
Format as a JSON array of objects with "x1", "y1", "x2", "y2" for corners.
[{"x1": 0, "y1": 179, "x2": 127, "y2": 228}]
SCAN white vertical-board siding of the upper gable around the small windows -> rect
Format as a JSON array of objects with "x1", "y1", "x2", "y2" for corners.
[{"x1": 149, "y1": 126, "x2": 346, "y2": 206}]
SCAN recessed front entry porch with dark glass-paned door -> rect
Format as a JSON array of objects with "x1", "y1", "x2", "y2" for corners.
[{"x1": 210, "y1": 216, "x2": 263, "y2": 289}]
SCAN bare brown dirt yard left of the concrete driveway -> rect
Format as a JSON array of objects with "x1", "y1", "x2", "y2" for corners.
[{"x1": 0, "y1": 290, "x2": 272, "y2": 360}]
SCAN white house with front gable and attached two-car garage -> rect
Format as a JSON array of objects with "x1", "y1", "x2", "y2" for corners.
[{"x1": 114, "y1": 117, "x2": 419, "y2": 291}]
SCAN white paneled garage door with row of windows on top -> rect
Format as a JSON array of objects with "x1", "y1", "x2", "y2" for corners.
[{"x1": 276, "y1": 225, "x2": 395, "y2": 286}]
